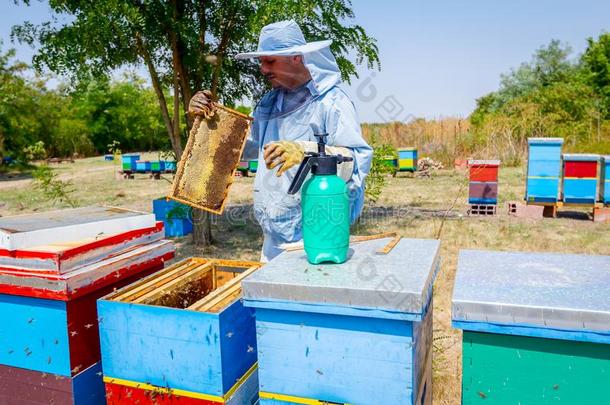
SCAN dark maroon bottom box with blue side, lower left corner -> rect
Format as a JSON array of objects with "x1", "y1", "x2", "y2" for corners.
[{"x1": 0, "y1": 362, "x2": 106, "y2": 405}]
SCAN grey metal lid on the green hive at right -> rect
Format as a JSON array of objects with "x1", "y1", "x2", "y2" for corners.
[{"x1": 452, "y1": 250, "x2": 610, "y2": 334}]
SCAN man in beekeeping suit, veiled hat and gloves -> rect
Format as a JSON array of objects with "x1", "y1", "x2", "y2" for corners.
[{"x1": 189, "y1": 21, "x2": 372, "y2": 262}]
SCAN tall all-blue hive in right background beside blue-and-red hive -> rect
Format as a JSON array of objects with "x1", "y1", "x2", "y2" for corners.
[{"x1": 525, "y1": 138, "x2": 563, "y2": 203}]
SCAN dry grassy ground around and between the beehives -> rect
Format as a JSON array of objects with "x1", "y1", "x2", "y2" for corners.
[{"x1": 0, "y1": 154, "x2": 610, "y2": 404}]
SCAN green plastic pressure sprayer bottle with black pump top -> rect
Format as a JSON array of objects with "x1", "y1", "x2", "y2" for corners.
[{"x1": 288, "y1": 134, "x2": 352, "y2": 264}]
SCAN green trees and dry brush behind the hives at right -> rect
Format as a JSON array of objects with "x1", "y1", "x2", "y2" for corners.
[{"x1": 470, "y1": 34, "x2": 610, "y2": 155}]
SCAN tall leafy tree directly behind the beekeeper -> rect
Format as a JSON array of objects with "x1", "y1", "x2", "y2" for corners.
[{"x1": 13, "y1": 0, "x2": 379, "y2": 245}]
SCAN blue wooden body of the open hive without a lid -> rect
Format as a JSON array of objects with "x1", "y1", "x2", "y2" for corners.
[{"x1": 98, "y1": 300, "x2": 256, "y2": 396}]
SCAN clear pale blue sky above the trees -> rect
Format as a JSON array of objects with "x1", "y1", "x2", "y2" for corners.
[{"x1": 0, "y1": 0, "x2": 610, "y2": 122}]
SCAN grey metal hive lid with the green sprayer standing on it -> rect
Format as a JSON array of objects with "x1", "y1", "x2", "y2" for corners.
[{"x1": 242, "y1": 238, "x2": 440, "y2": 317}]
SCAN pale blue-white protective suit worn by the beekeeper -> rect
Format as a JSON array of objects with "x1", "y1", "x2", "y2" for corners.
[{"x1": 236, "y1": 24, "x2": 372, "y2": 261}]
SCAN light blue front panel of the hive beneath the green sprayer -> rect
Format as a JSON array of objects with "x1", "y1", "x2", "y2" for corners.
[{"x1": 256, "y1": 308, "x2": 416, "y2": 404}]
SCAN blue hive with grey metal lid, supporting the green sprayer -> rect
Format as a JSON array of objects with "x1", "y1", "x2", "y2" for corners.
[{"x1": 242, "y1": 238, "x2": 440, "y2": 405}]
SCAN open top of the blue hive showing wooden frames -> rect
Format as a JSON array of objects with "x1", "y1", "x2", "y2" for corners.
[{"x1": 109, "y1": 258, "x2": 260, "y2": 312}]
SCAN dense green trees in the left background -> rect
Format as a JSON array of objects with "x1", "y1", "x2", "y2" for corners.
[{"x1": 0, "y1": 41, "x2": 169, "y2": 160}]
